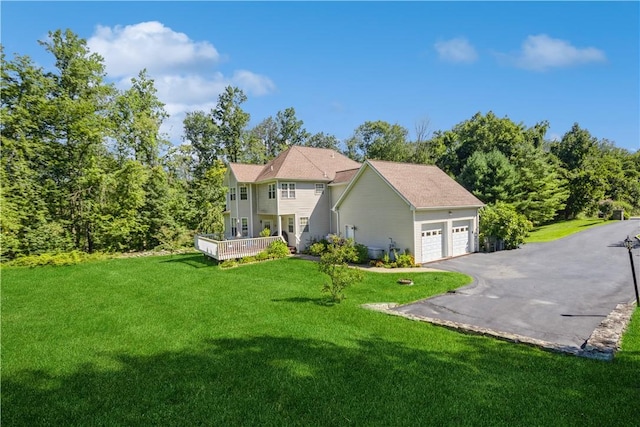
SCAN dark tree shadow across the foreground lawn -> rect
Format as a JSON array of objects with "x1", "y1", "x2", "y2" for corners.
[{"x1": 2, "y1": 336, "x2": 638, "y2": 426}]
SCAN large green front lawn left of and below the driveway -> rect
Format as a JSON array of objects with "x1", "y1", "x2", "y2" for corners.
[{"x1": 1, "y1": 255, "x2": 640, "y2": 426}]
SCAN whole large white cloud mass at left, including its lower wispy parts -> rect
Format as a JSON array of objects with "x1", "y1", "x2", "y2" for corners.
[{"x1": 87, "y1": 21, "x2": 276, "y2": 143}]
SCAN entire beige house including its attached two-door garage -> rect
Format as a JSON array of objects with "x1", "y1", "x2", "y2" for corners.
[{"x1": 225, "y1": 146, "x2": 483, "y2": 263}]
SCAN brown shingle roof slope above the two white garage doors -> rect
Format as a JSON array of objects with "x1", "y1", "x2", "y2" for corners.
[{"x1": 367, "y1": 160, "x2": 484, "y2": 209}]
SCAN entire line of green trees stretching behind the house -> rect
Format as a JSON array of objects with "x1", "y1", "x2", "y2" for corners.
[{"x1": 0, "y1": 30, "x2": 640, "y2": 259}]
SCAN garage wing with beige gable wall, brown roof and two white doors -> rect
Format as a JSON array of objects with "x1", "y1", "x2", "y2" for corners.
[{"x1": 333, "y1": 160, "x2": 483, "y2": 263}]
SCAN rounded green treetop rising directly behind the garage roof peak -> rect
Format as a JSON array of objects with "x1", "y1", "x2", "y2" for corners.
[{"x1": 346, "y1": 120, "x2": 412, "y2": 162}]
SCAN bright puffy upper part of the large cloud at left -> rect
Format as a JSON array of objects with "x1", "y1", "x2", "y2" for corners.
[{"x1": 87, "y1": 21, "x2": 220, "y2": 77}]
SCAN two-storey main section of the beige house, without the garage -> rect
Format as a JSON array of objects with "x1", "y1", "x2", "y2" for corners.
[{"x1": 225, "y1": 146, "x2": 360, "y2": 250}]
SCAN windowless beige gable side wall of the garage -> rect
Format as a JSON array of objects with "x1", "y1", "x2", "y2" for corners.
[{"x1": 338, "y1": 168, "x2": 416, "y2": 254}]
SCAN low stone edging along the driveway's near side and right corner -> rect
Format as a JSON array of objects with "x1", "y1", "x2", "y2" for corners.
[{"x1": 361, "y1": 302, "x2": 635, "y2": 360}]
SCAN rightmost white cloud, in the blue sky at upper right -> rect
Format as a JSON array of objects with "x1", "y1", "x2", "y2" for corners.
[{"x1": 513, "y1": 34, "x2": 607, "y2": 71}]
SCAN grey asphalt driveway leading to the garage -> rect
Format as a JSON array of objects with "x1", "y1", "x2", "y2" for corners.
[{"x1": 392, "y1": 221, "x2": 640, "y2": 347}]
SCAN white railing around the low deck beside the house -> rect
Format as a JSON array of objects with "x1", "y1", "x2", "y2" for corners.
[{"x1": 195, "y1": 234, "x2": 284, "y2": 261}]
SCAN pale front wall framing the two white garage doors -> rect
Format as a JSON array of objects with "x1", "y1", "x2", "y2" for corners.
[{"x1": 413, "y1": 208, "x2": 478, "y2": 263}]
